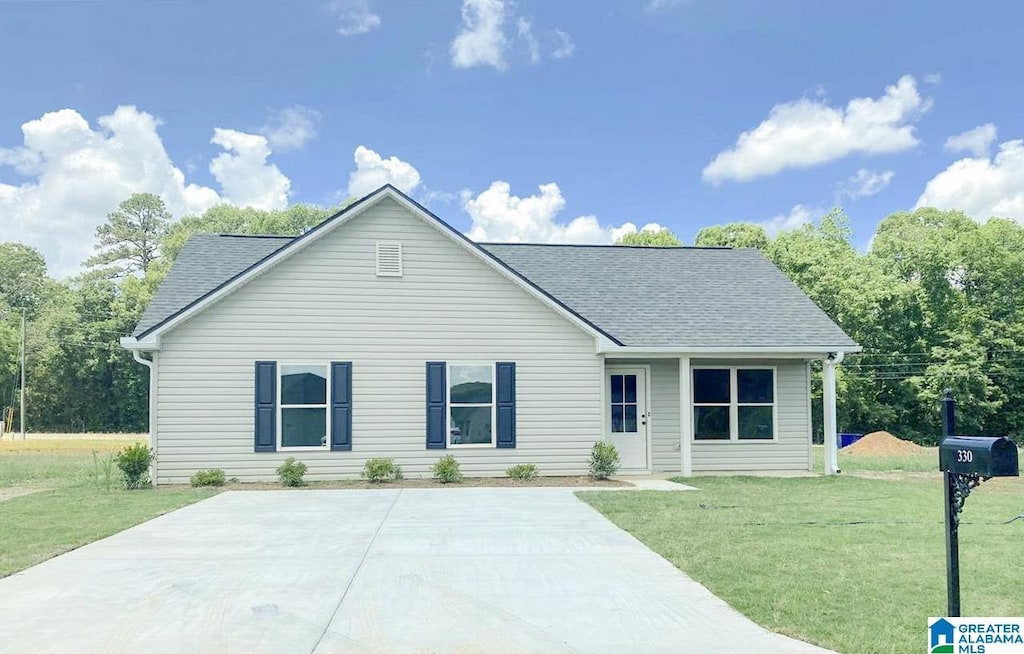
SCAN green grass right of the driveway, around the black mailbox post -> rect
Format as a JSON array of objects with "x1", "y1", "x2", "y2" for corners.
[{"x1": 579, "y1": 452, "x2": 1024, "y2": 653}]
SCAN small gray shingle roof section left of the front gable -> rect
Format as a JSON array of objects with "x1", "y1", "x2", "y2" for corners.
[{"x1": 132, "y1": 234, "x2": 292, "y2": 336}]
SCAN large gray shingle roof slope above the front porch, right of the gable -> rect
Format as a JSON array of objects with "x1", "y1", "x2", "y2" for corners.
[{"x1": 481, "y1": 244, "x2": 856, "y2": 348}]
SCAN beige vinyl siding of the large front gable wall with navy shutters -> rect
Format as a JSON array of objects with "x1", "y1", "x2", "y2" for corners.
[{"x1": 151, "y1": 200, "x2": 602, "y2": 483}]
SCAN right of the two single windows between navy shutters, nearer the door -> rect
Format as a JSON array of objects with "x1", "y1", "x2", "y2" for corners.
[{"x1": 447, "y1": 363, "x2": 495, "y2": 446}]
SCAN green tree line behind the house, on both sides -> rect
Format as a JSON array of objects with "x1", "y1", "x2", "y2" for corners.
[{"x1": 0, "y1": 193, "x2": 1024, "y2": 443}]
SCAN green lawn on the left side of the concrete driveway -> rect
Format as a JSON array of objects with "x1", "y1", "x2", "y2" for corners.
[{"x1": 0, "y1": 440, "x2": 213, "y2": 577}]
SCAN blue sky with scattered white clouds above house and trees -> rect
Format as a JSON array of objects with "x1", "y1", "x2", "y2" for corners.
[{"x1": 0, "y1": 0, "x2": 1024, "y2": 274}]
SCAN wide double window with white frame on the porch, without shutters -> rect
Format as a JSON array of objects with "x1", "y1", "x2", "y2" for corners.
[{"x1": 693, "y1": 367, "x2": 775, "y2": 441}]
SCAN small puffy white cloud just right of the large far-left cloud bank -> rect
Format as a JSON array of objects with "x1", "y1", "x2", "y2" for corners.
[{"x1": 210, "y1": 127, "x2": 292, "y2": 209}]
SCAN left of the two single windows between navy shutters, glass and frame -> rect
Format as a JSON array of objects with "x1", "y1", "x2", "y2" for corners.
[{"x1": 278, "y1": 364, "x2": 329, "y2": 449}]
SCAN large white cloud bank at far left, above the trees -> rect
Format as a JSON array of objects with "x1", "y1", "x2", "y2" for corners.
[{"x1": 0, "y1": 106, "x2": 288, "y2": 276}]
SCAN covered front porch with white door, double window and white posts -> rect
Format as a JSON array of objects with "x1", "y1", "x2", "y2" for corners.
[{"x1": 601, "y1": 350, "x2": 843, "y2": 476}]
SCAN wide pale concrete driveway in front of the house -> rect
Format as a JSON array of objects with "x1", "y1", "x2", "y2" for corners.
[{"x1": 0, "y1": 488, "x2": 824, "y2": 654}]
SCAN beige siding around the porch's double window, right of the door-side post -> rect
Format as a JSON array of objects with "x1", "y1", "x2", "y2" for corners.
[{"x1": 690, "y1": 359, "x2": 811, "y2": 472}]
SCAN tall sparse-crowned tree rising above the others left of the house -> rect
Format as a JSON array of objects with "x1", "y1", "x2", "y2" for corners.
[{"x1": 85, "y1": 193, "x2": 171, "y2": 275}]
